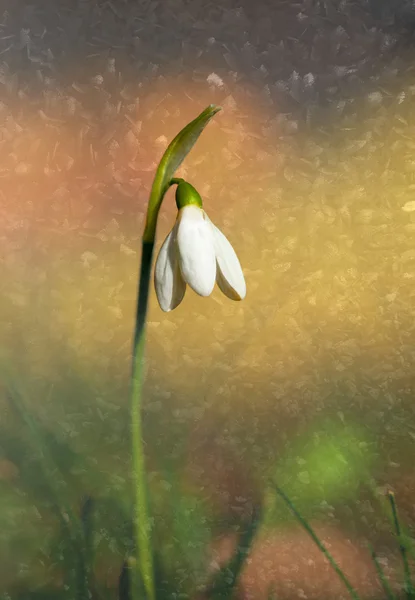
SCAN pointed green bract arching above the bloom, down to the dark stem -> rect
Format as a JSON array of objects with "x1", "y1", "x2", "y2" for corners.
[{"x1": 143, "y1": 104, "x2": 221, "y2": 242}]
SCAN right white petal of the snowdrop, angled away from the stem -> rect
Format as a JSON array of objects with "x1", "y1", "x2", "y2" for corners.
[{"x1": 209, "y1": 219, "x2": 246, "y2": 300}]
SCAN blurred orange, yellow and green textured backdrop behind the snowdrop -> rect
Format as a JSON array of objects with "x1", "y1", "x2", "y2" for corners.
[{"x1": 0, "y1": 0, "x2": 415, "y2": 600}]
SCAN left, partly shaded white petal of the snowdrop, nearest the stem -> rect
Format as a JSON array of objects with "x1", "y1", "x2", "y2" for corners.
[{"x1": 154, "y1": 224, "x2": 186, "y2": 312}]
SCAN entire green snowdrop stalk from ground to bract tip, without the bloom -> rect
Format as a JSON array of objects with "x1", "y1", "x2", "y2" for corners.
[{"x1": 131, "y1": 104, "x2": 220, "y2": 600}]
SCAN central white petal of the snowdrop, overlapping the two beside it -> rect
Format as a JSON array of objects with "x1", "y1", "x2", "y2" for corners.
[{"x1": 177, "y1": 205, "x2": 216, "y2": 296}]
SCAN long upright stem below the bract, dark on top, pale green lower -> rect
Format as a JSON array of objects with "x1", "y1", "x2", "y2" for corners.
[{"x1": 131, "y1": 241, "x2": 155, "y2": 600}]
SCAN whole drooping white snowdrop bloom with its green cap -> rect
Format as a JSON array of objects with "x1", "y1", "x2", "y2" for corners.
[{"x1": 154, "y1": 181, "x2": 246, "y2": 312}]
